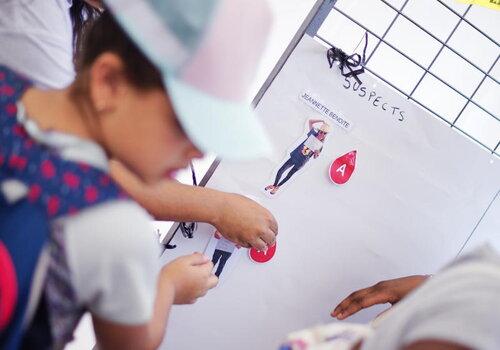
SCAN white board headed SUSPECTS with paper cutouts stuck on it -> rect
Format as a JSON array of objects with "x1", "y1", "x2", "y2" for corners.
[{"x1": 157, "y1": 36, "x2": 500, "y2": 350}]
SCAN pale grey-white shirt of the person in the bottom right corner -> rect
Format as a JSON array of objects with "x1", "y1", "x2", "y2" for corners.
[{"x1": 362, "y1": 246, "x2": 500, "y2": 350}]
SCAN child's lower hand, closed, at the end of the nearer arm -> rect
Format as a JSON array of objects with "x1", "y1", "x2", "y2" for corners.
[{"x1": 162, "y1": 253, "x2": 218, "y2": 304}]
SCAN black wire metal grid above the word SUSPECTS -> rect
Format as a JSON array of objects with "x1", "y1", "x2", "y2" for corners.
[{"x1": 309, "y1": 0, "x2": 500, "y2": 156}]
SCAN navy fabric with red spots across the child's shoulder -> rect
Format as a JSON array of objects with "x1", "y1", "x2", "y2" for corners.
[{"x1": 0, "y1": 66, "x2": 126, "y2": 219}]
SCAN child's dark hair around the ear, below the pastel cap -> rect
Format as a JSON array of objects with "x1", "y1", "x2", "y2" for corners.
[{"x1": 76, "y1": 10, "x2": 163, "y2": 89}]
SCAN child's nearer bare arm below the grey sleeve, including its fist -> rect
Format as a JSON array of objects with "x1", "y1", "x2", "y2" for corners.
[{"x1": 92, "y1": 253, "x2": 218, "y2": 349}]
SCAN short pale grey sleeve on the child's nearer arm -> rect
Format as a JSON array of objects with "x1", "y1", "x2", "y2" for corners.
[{"x1": 64, "y1": 201, "x2": 160, "y2": 324}]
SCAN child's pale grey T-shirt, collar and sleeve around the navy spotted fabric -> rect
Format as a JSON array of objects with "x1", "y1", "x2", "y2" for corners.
[{"x1": 0, "y1": 103, "x2": 161, "y2": 348}]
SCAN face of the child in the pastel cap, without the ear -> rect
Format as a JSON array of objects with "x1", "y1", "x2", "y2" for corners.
[{"x1": 107, "y1": 89, "x2": 203, "y2": 183}]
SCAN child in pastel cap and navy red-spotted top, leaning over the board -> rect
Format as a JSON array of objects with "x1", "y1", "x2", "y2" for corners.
[{"x1": 0, "y1": 0, "x2": 276, "y2": 349}]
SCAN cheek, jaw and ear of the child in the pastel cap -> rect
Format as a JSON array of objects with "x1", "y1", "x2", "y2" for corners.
[{"x1": 90, "y1": 55, "x2": 203, "y2": 183}]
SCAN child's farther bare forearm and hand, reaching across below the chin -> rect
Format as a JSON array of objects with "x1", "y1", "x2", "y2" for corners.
[{"x1": 110, "y1": 161, "x2": 278, "y2": 250}]
